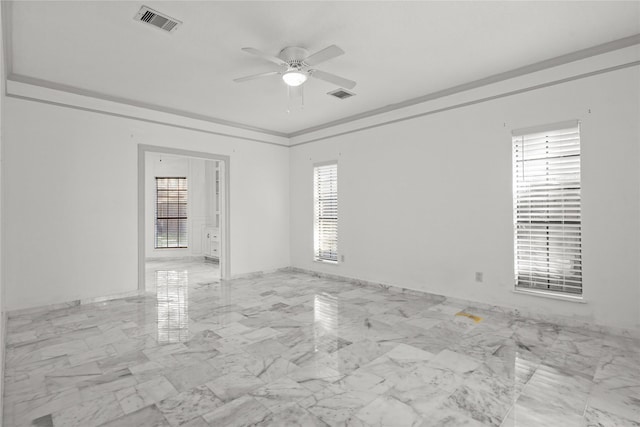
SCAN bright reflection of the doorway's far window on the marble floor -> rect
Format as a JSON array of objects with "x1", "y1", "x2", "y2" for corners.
[{"x1": 156, "y1": 270, "x2": 189, "y2": 344}]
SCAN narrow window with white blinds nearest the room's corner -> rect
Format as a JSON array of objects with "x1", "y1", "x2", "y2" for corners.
[{"x1": 313, "y1": 163, "x2": 338, "y2": 263}]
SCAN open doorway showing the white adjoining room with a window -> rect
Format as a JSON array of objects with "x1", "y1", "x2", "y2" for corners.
[{"x1": 138, "y1": 145, "x2": 230, "y2": 292}]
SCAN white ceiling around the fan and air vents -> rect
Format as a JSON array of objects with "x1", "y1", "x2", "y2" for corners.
[{"x1": 6, "y1": 0, "x2": 640, "y2": 134}]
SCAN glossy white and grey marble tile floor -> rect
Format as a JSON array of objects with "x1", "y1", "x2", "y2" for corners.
[{"x1": 4, "y1": 265, "x2": 640, "y2": 427}]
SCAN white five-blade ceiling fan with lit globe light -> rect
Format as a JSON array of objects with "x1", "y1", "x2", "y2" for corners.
[{"x1": 233, "y1": 45, "x2": 356, "y2": 108}]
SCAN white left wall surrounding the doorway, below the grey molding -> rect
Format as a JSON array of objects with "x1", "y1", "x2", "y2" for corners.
[{"x1": 4, "y1": 98, "x2": 289, "y2": 310}]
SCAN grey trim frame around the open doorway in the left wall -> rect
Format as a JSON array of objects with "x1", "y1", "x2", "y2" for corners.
[{"x1": 138, "y1": 144, "x2": 231, "y2": 292}]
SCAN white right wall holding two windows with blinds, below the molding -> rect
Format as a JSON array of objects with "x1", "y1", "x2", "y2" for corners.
[{"x1": 290, "y1": 66, "x2": 640, "y2": 328}]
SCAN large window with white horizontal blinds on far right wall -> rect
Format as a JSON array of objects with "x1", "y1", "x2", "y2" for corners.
[{"x1": 513, "y1": 121, "x2": 582, "y2": 297}]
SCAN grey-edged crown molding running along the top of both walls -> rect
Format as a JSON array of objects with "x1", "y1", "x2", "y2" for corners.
[{"x1": 1, "y1": 1, "x2": 640, "y2": 147}]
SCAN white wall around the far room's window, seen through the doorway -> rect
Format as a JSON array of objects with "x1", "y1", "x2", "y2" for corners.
[{"x1": 145, "y1": 153, "x2": 216, "y2": 258}]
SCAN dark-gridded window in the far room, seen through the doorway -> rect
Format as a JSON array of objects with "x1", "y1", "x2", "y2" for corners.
[{"x1": 156, "y1": 178, "x2": 187, "y2": 249}]
